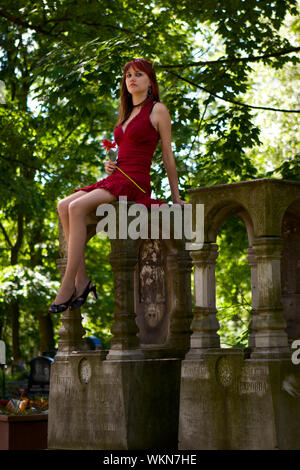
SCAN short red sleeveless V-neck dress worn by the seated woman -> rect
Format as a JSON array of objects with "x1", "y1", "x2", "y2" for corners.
[{"x1": 74, "y1": 101, "x2": 166, "y2": 209}]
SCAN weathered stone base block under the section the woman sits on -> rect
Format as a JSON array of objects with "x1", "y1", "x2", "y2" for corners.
[{"x1": 48, "y1": 351, "x2": 180, "y2": 450}]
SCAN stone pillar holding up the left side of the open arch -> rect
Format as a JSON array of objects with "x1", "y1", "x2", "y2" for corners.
[{"x1": 186, "y1": 243, "x2": 220, "y2": 359}]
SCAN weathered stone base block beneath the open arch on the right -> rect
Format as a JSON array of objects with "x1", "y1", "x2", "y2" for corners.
[{"x1": 179, "y1": 349, "x2": 300, "y2": 450}]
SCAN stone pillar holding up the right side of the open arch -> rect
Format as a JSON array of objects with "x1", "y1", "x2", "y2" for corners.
[{"x1": 251, "y1": 237, "x2": 290, "y2": 359}]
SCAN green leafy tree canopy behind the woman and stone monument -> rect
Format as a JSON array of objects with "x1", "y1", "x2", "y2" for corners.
[{"x1": 0, "y1": 0, "x2": 299, "y2": 359}]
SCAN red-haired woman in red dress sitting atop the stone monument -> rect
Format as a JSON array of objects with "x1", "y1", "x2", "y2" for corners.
[{"x1": 49, "y1": 59, "x2": 185, "y2": 313}]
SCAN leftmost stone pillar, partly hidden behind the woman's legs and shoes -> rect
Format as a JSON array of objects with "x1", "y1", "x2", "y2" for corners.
[{"x1": 55, "y1": 219, "x2": 85, "y2": 360}]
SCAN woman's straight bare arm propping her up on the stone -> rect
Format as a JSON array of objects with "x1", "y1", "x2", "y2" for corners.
[{"x1": 151, "y1": 103, "x2": 187, "y2": 204}]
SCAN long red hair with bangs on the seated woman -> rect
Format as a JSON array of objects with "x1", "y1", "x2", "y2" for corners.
[{"x1": 116, "y1": 59, "x2": 159, "y2": 126}]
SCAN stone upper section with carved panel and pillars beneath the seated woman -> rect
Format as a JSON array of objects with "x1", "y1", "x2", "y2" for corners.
[{"x1": 56, "y1": 202, "x2": 192, "y2": 360}]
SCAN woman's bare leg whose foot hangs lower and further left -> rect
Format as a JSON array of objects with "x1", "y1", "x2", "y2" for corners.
[{"x1": 54, "y1": 189, "x2": 117, "y2": 304}]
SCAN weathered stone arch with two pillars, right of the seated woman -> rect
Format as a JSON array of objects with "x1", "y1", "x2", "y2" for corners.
[{"x1": 188, "y1": 178, "x2": 300, "y2": 359}]
